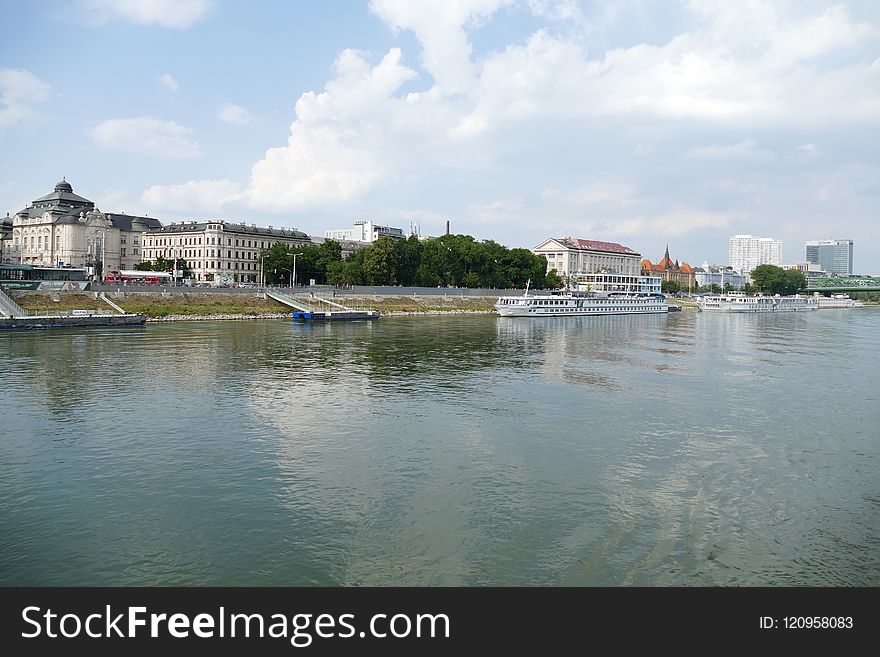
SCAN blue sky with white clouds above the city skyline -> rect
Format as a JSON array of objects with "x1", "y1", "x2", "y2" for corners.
[{"x1": 0, "y1": 0, "x2": 880, "y2": 275}]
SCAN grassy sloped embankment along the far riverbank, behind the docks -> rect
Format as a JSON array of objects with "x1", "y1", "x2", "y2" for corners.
[{"x1": 15, "y1": 292, "x2": 495, "y2": 319}]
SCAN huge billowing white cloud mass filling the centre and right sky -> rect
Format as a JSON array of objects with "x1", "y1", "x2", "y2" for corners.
[{"x1": 138, "y1": 0, "x2": 880, "y2": 266}]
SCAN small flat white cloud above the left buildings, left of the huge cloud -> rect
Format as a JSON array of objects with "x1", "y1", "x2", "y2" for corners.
[{"x1": 89, "y1": 116, "x2": 199, "y2": 157}]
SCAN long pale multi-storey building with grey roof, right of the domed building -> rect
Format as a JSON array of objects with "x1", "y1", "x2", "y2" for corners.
[{"x1": 143, "y1": 220, "x2": 312, "y2": 285}]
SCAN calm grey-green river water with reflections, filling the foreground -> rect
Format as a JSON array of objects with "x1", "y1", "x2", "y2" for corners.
[{"x1": 0, "y1": 309, "x2": 880, "y2": 585}]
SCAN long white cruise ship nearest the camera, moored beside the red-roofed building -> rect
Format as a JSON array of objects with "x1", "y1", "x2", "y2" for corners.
[{"x1": 495, "y1": 290, "x2": 669, "y2": 317}]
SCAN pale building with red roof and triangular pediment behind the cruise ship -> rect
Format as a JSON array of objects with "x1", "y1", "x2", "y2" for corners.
[{"x1": 532, "y1": 237, "x2": 641, "y2": 279}]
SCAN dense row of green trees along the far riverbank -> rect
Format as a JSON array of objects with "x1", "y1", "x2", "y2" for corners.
[{"x1": 260, "y1": 235, "x2": 562, "y2": 288}]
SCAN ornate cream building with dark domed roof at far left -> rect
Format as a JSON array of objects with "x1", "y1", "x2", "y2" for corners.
[{"x1": 2, "y1": 180, "x2": 162, "y2": 277}]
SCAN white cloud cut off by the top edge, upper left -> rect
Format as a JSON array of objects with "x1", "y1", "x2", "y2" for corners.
[{"x1": 82, "y1": 0, "x2": 214, "y2": 29}]
